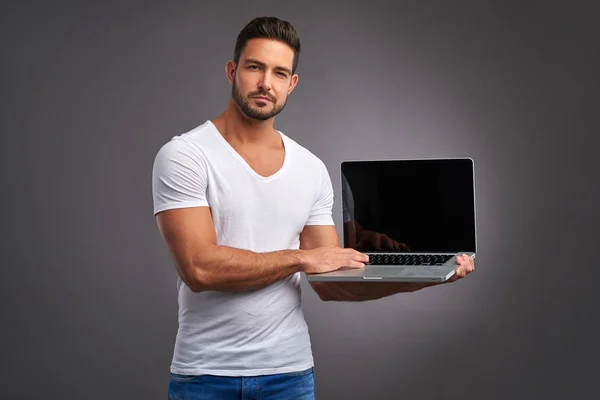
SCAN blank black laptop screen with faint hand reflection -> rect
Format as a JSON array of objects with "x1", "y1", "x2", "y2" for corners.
[{"x1": 341, "y1": 159, "x2": 476, "y2": 253}]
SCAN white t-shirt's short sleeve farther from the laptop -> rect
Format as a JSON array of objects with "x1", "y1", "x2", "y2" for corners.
[{"x1": 152, "y1": 139, "x2": 208, "y2": 215}]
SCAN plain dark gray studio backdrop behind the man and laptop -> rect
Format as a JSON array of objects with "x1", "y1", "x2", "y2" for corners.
[{"x1": 0, "y1": 1, "x2": 600, "y2": 399}]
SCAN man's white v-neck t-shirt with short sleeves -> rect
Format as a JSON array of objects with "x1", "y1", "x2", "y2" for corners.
[{"x1": 152, "y1": 121, "x2": 333, "y2": 376}]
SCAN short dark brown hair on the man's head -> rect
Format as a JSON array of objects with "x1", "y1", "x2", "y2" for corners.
[{"x1": 233, "y1": 17, "x2": 300, "y2": 73}]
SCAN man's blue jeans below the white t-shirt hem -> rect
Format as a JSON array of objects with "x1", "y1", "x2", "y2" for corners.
[{"x1": 169, "y1": 368, "x2": 315, "y2": 400}]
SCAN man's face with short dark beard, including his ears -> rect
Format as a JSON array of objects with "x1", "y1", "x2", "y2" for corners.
[{"x1": 227, "y1": 39, "x2": 298, "y2": 121}]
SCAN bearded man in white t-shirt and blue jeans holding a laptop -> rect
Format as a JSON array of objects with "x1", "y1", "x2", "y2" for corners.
[{"x1": 152, "y1": 18, "x2": 472, "y2": 400}]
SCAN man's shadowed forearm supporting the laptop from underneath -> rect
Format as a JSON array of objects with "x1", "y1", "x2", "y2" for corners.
[{"x1": 311, "y1": 282, "x2": 437, "y2": 301}]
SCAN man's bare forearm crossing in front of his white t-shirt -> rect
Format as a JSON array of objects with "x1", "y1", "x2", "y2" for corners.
[{"x1": 192, "y1": 245, "x2": 303, "y2": 292}]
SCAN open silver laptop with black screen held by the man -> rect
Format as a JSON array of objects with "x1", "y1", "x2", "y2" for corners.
[{"x1": 307, "y1": 158, "x2": 477, "y2": 282}]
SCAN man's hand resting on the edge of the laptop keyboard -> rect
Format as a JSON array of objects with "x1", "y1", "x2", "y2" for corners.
[{"x1": 300, "y1": 246, "x2": 369, "y2": 274}]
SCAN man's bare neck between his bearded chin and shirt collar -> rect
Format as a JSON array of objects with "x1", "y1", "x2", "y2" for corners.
[{"x1": 212, "y1": 99, "x2": 279, "y2": 144}]
